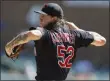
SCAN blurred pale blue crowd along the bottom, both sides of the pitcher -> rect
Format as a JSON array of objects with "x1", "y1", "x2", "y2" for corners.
[{"x1": 1, "y1": 55, "x2": 109, "y2": 80}]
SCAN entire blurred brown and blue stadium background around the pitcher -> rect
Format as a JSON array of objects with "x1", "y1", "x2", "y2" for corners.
[{"x1": 0, "y1": 1, "x2": 110, "y2": 80}]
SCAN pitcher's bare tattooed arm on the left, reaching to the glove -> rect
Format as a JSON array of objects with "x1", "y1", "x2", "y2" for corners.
[{"x1": 5, "y1": 30, "x2": 42, "y2": 55}]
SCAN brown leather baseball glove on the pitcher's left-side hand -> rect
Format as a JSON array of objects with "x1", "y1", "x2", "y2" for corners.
[{"x1": 6, "y1": 44, "x2": 24, "y2": 60}]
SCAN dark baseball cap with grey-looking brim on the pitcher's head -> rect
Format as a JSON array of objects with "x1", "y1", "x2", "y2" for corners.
[{"x1": 34, "y1": 3, "x2": 64, "y2": 18}]
